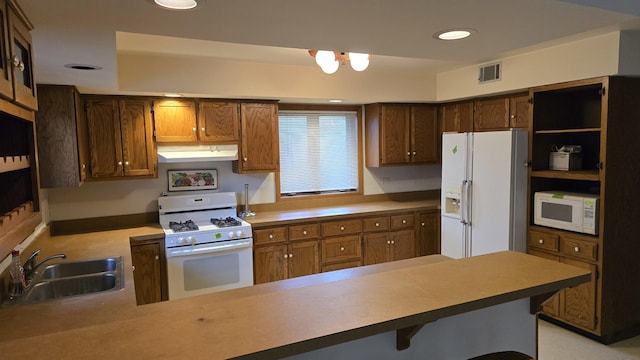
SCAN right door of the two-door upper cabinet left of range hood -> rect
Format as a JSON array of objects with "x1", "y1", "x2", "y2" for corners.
[{"x1": 119, "y1": 99, "x2": 156, "y2": 176}]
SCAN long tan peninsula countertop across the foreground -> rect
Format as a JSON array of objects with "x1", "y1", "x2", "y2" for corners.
[{"x1": 0, "y1": 252, "x2": 591, "y2": 359}]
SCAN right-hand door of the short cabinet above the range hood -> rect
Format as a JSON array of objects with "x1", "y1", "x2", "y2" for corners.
[{"x1": 198, "y1": 101, "x2": 240, "y2": 142}]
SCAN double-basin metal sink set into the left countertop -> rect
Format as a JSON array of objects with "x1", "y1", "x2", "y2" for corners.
[{"x1": 4, "y1": 256, "x2": 124, "y2": 305}]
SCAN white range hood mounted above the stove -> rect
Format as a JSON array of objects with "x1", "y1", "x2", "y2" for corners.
[{"x1": 158, "y1": 144, "x2": 238, "y2": 163}]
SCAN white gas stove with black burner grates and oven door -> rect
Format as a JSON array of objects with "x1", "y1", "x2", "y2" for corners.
[{"x1": 158, "y1": 193, "x2": 253, "y2": 300}]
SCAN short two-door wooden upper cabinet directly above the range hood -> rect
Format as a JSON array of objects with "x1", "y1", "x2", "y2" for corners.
[{"x1": 153, "y1": 100, "x2": 240, "y2": 143}]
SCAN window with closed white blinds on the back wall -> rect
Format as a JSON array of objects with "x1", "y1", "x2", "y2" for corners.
[{"x1": 278, "y1": 109, "x2": 360, "y2": 197}]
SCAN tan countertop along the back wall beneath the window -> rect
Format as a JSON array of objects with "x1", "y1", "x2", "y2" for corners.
[{"x1": 245, "y1": 199, "x2": 440, "y2": 227}]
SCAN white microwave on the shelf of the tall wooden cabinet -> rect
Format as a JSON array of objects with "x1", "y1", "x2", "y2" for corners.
[{"x1": 533, "y1": 191, "x2": 600, "y2": 235}]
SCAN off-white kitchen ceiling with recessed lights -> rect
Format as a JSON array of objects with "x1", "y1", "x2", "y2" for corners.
[{"x1": 18, "y1": 0, "x2": 640, "y2": 99}]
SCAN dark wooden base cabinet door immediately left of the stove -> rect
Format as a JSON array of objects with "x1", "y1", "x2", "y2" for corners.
[{"x1": 131, "y1": 244, "x2": 162, "y2": 305}]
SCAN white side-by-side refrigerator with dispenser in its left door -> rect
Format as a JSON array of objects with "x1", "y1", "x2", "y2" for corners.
[{"x1": 441, "y1": 130, "x2": 528, "y2": 259}]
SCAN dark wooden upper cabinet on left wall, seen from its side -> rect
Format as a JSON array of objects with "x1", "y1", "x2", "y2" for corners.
[{"x1": 36, "y1": 85, "x2": 89, "y2": 188}]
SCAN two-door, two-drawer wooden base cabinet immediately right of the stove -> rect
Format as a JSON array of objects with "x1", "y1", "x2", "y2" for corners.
[{"x1": 253, "y1": 224, "x2": 320, "y2": 284}]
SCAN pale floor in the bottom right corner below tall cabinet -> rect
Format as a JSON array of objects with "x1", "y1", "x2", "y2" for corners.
[{"x1": 538, "y1": 320, "x2": 640, "y2": 360}]
